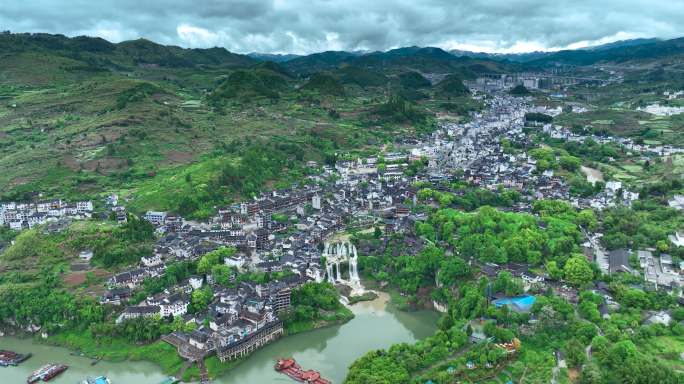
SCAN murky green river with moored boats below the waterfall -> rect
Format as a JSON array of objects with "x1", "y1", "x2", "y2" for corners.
[{"x1": 0, "y1": 292, "x2": 438, "y2": 384}]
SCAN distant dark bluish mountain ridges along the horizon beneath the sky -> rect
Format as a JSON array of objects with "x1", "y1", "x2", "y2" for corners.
[{"x1": 5, "y1": 32, "x2": 684, "y2": 77}]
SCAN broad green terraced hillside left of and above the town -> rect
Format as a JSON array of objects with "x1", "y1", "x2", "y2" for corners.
[{"x1": 0, "y1": 33, "x2": 484, "y2": 217}]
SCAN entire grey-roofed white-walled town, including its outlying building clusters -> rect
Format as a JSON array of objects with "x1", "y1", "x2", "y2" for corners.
[{"x1": 1, "y1": 89, "x2": 664, "y2": 376}]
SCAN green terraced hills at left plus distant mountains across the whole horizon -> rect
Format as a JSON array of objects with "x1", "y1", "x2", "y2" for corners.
[{"x1": 0, "y1": 33, "x2": 684, "y2": 212}]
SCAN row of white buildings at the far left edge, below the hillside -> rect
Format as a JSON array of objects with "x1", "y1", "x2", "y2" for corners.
[{"x1": 0, "y1": 199, "x2": 93, "y2": 231}]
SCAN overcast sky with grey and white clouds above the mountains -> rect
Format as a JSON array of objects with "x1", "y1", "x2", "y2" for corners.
[{"x1": 0, "y1": 0, "x2": 684, "y2": 54}]
